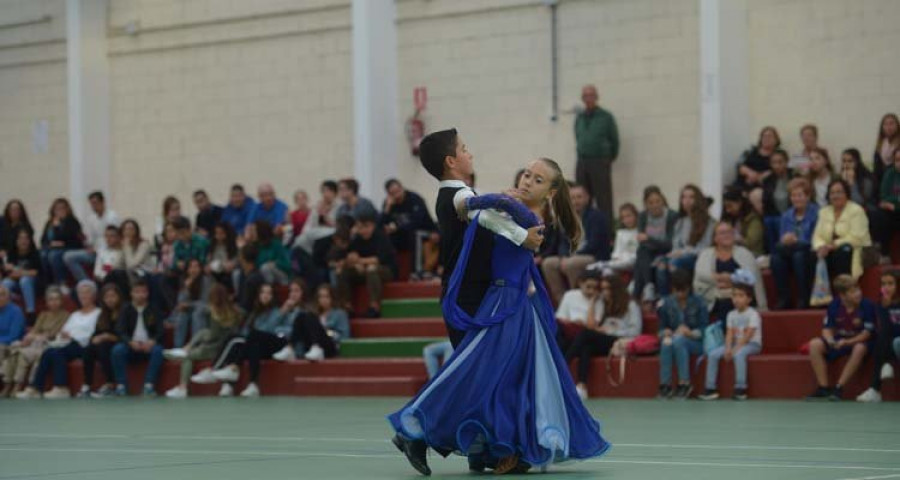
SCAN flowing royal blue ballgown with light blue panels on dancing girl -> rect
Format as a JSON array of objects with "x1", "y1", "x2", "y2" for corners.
[{"x1": 388, "y1": 195, "x2": 610, "y2": 467}]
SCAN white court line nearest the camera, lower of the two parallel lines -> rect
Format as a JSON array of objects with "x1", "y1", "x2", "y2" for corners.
[{"x1": 0, "y1": 447, "x2": 900, "y2": 472}]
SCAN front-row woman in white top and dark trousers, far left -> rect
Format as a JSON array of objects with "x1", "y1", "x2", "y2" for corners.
[{"x1": 18, "y1": 280, "x2": 100, "y2": 399}]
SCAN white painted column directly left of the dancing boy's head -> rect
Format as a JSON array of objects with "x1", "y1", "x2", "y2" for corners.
[{"x1": 352, "y1": 0, "x2": 400, "y2": 206}]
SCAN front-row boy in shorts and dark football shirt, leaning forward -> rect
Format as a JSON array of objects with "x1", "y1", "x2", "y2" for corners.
[{"x1": 806, "y1": 275, "x2": 877, "y2": 401}]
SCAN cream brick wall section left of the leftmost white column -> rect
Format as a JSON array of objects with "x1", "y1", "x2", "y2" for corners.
[{"x1": 0, "y1": 0, "x2": 69, "y2": 229}]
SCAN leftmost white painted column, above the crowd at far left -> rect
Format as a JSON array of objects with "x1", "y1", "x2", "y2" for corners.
[{"x1": 66, "y1": 0, "x2": 111, "y2": 215}]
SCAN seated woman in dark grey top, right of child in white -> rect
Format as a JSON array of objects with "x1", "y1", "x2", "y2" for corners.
[{"x1": 632, "y1": 185, "x2": 678, "y2": 301}]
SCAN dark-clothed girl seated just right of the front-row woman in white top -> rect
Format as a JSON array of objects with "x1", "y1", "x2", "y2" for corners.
[{"x1": 78, "y1": 284, "x2": 125, "y2": 398}]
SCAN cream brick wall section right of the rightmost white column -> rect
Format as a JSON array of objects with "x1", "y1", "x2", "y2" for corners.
[{"x1": 748, "y1": 0, "x2": 900, "y2": 169}]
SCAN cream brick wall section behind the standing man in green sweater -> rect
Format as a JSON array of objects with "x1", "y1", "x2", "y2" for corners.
[{"x1": 398, "y1": 0, "x2": 699, "y2": 216}]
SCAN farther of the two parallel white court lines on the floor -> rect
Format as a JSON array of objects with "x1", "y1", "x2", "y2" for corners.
[{"x1": 0, "y1": 433, "x2": 900, "y2": 454}]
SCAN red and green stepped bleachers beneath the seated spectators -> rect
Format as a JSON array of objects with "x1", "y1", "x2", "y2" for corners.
[{"x1": 24, "y1": 260, "x2": 900, "y2": 400}]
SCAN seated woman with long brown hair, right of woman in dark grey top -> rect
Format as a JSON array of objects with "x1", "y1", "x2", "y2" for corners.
[{"x1": 656, "y1": 184, "x2": 715, "y2": 296}]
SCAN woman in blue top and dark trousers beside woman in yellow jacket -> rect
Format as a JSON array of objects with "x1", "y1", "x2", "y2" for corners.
[{"x1": 771, "y1": 178, "x2": 819, "y2": 310}]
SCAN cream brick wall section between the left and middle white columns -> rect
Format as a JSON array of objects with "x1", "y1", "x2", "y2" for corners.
[{"x1": 110, "y1": 0, "x2": 353, "y2": 232}]
